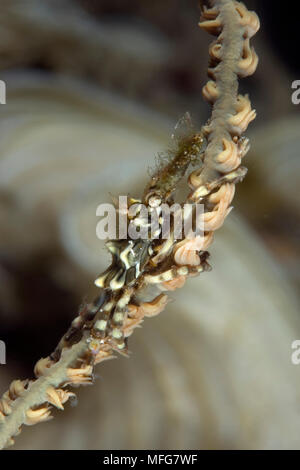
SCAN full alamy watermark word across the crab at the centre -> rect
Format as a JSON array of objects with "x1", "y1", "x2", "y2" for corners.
[{"x1": 96, "y1": 196, "x2": 204, "y2": 240}]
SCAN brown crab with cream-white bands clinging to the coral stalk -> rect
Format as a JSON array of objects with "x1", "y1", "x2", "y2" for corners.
[{"x1": 91, "y1": 132, "x2": 204, "y2": 352}]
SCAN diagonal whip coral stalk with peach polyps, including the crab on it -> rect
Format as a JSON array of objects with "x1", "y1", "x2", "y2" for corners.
[{"x1": 0, "y1": 0, "x2": 259, "y2": 448}]
